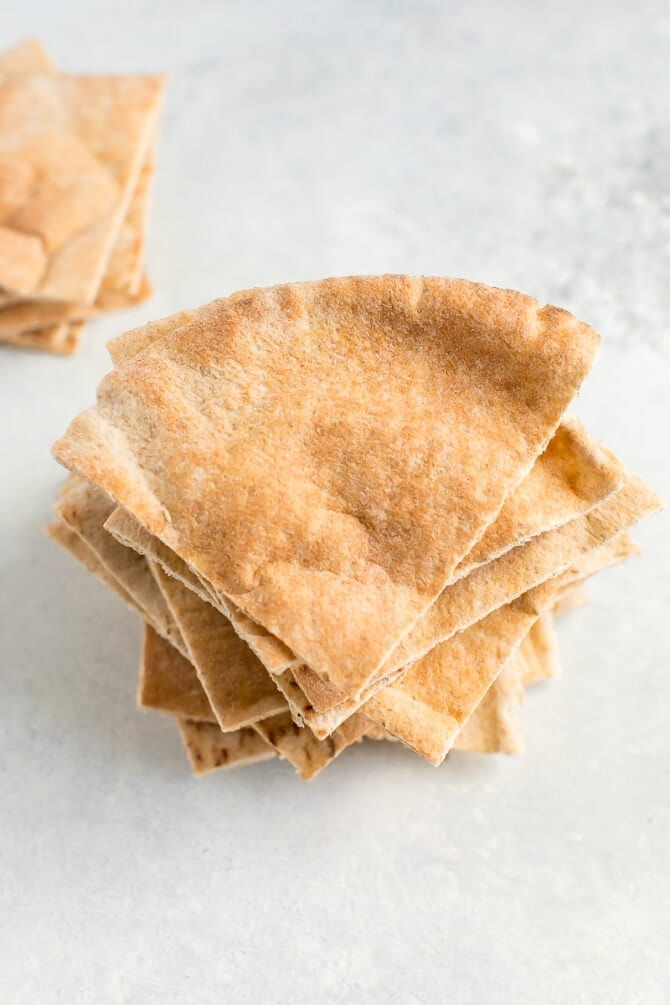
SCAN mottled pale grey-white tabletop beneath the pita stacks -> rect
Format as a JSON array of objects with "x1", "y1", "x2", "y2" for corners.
[{"x1": 0, "y1": 0, "x2": 670, "y2": 1005}]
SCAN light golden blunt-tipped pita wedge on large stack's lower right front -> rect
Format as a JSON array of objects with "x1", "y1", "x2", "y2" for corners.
[{"x1": 362, "y1": 526, "x2": 650, "y2": 764}]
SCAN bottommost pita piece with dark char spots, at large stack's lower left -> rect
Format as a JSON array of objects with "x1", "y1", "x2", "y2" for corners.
[{"x1": 179, "y1": 719, "x2": 276, "y2": 775}]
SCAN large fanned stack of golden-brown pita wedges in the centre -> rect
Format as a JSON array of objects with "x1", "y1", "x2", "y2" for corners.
[{"x1": 49, "y1": 275, "x2": 659, "y2": 779}]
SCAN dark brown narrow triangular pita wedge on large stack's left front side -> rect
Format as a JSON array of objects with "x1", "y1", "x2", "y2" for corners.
[{"x1": 149, "y1": 558, "x2": 286, "y2": 733}]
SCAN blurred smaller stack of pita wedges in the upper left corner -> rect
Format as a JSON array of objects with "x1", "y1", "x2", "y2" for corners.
[{"x1": 0, "y1": 41, "x2": 165, "y2": 353}]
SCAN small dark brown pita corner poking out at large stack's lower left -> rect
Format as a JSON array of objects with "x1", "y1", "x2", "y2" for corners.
[{"x1": 138, "y1": 624, "x2": 216, "y2": 723}]
